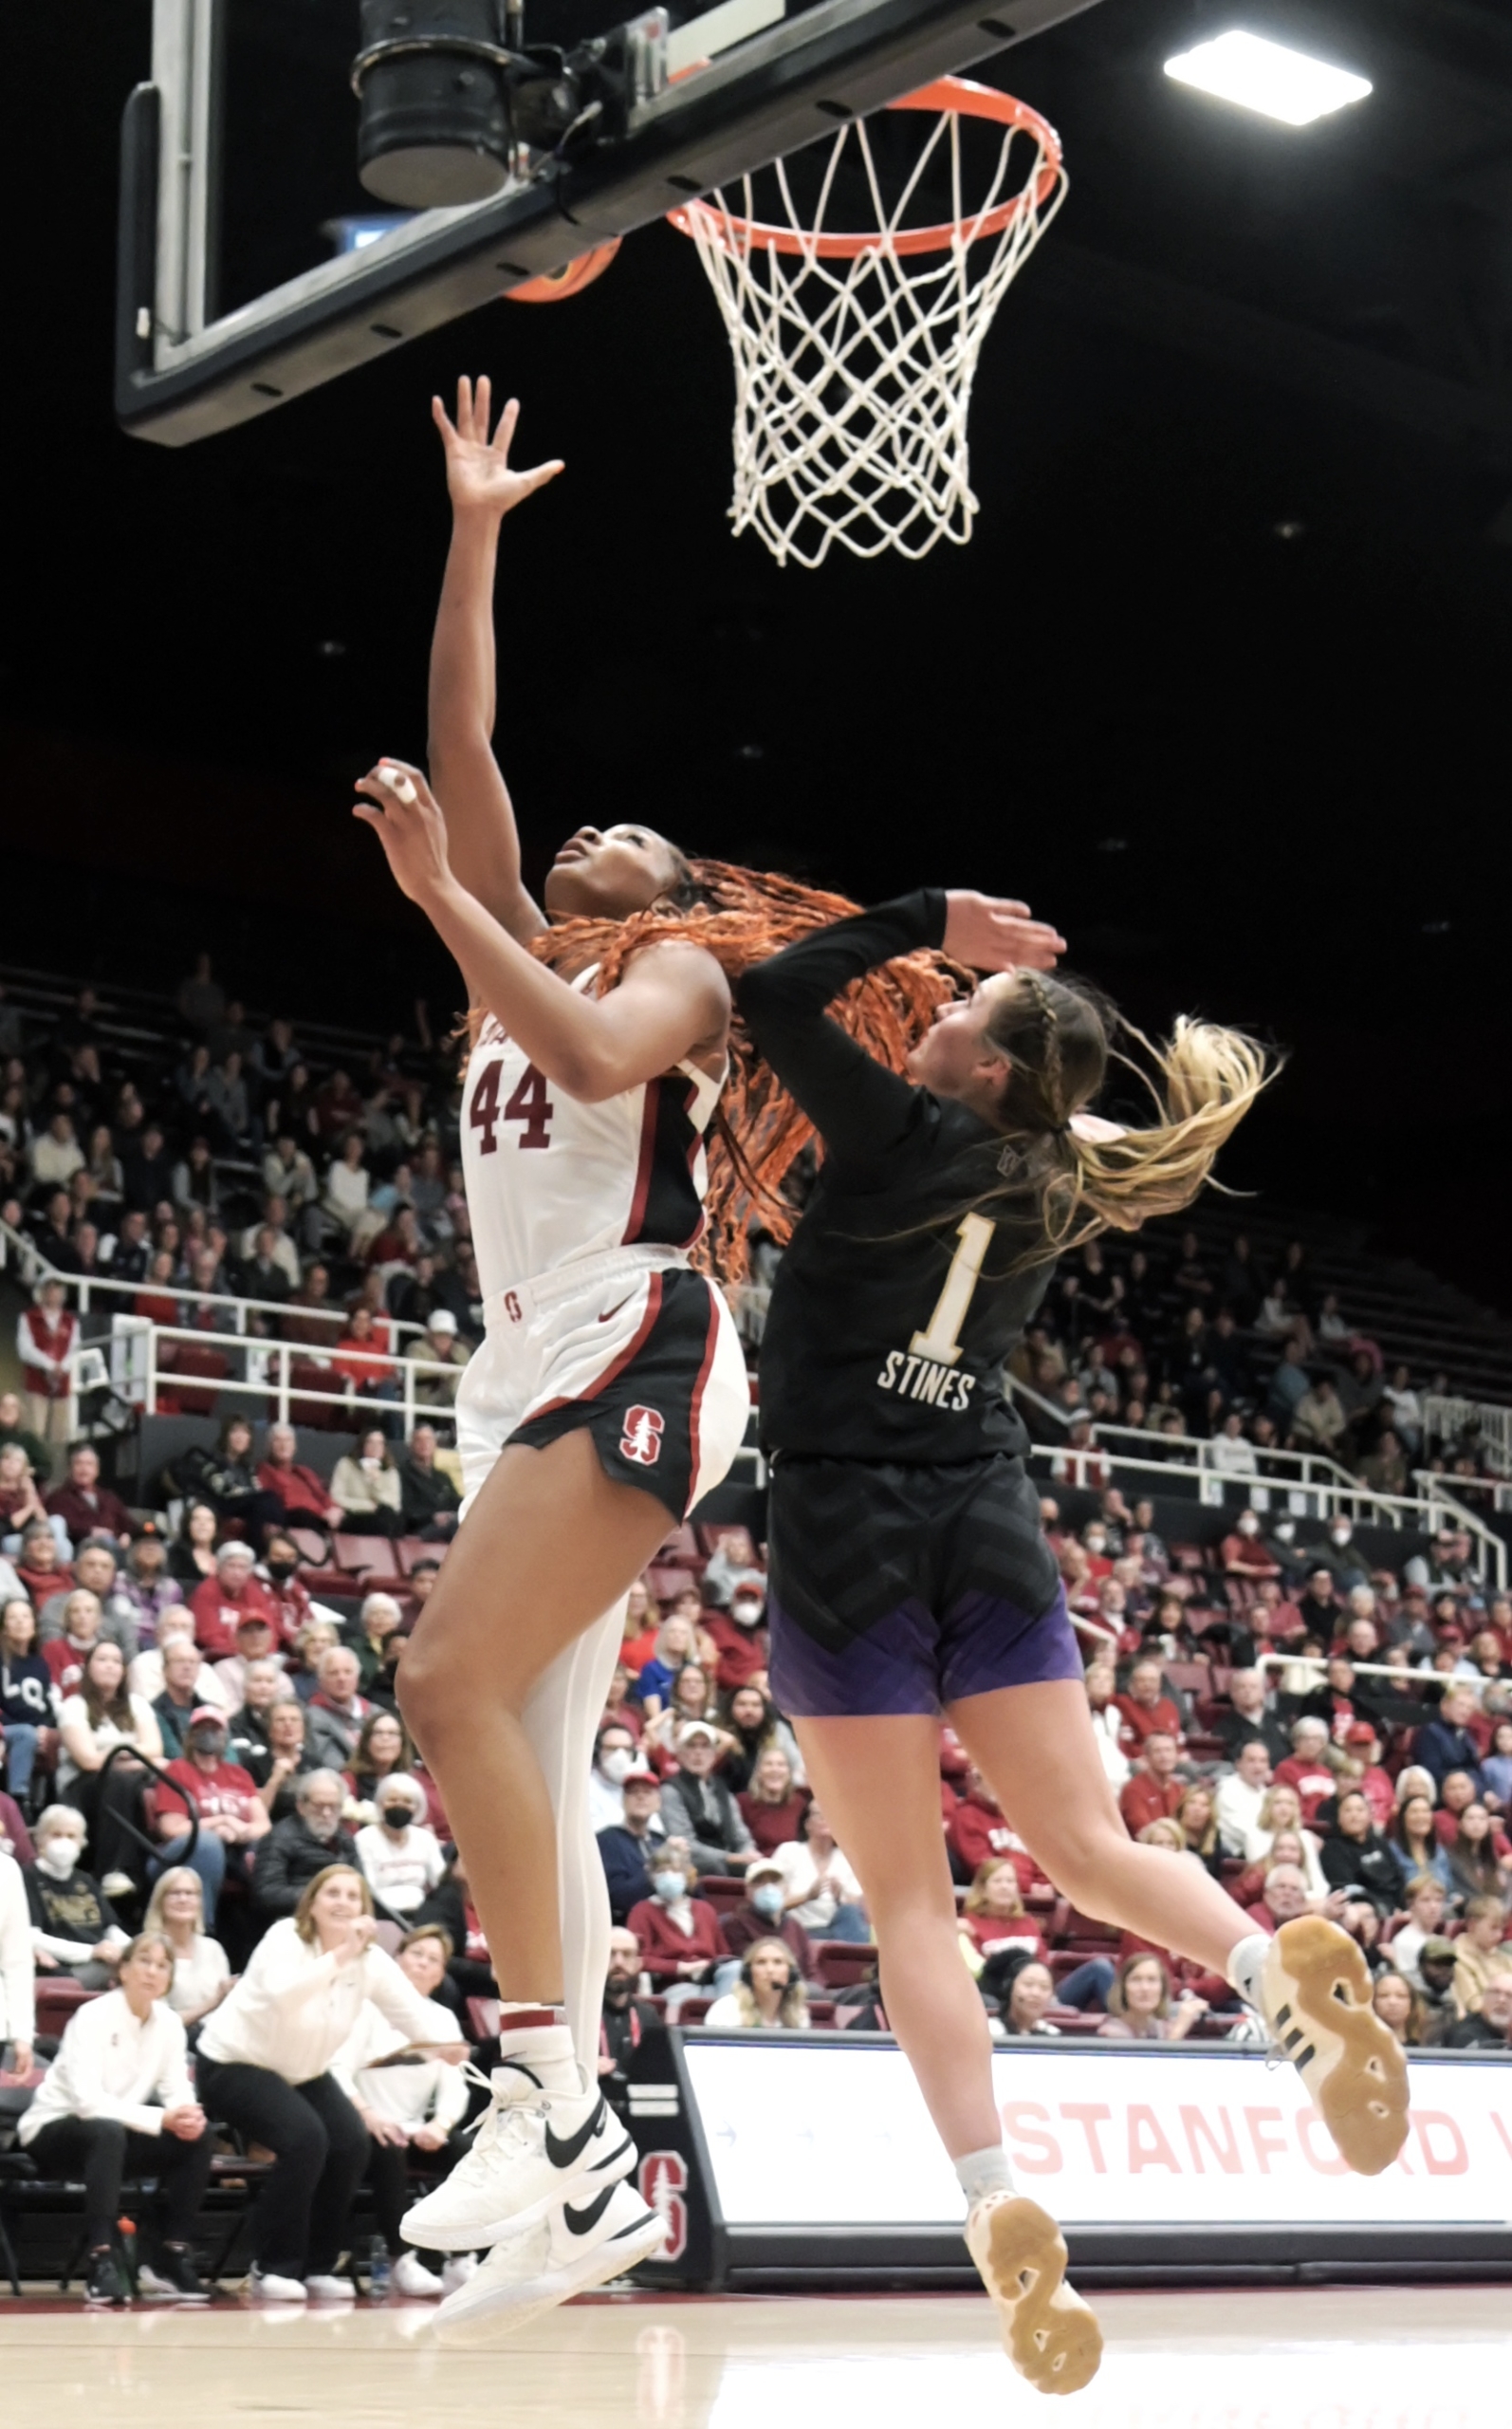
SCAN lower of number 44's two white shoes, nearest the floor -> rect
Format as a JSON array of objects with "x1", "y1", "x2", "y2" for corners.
[{"x1": 437, "y1": 2183, "x2": 668, "y2": 2344}]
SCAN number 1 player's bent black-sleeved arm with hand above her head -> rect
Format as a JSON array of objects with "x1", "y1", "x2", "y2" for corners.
[{"x1": 735, "y1": 886, "x2": 1063, "y2": 1161}]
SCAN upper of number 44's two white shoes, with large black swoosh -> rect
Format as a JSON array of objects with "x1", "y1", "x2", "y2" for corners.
[{"x1": 403, "y1": 2057, "x2": 636, "y2": 2252}]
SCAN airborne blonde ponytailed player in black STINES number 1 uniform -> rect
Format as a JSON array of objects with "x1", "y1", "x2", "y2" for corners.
[{"x1": 735, "y1": 892, "x2": 1408, "y2": 2393}]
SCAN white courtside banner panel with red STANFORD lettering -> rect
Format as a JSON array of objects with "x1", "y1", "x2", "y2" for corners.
[{"x1": 677, "y1": 2033, "x2": 1512, "y2": 2261}]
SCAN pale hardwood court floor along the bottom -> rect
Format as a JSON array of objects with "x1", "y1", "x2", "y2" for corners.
[{"x1": 0, "y1": 2286, "x2": 1512, "y2": 2429}]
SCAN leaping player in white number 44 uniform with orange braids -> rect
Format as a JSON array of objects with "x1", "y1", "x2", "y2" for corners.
[{"x1": 357, "y1": 381, "x2": 966, "y2": 2327}]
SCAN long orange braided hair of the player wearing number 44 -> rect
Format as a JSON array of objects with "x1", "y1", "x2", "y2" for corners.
[{"x1": 470, "y1": 860, "x2": 959, "y2": 1283}]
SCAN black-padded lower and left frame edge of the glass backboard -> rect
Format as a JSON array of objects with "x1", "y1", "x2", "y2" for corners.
[{"x1": 117, "y1": 0, "x2": 1097, "y2": 447}]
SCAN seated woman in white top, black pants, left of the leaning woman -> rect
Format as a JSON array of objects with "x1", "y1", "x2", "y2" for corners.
[{"x1": 17, "y1": 1931, "x2": 213, "y2": 2303}]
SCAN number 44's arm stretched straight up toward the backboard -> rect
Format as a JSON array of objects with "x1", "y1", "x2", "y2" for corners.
[{"x1": 430, "y1": 379, "x2": 563, "y2": 942}]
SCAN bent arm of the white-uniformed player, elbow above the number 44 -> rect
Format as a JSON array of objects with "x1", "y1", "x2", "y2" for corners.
[{"x1": 352, "y1": 760, "x2": 730, "y2": 1105}]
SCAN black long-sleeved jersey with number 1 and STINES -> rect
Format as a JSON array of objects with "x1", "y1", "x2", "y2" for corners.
[{"x1": 735, "y1": 892, "x2": 1051, "y2": 1462}]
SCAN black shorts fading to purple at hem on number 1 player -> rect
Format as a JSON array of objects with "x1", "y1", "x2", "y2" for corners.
[{"x1": 767, "y1": 1453, "x2": 1085, "y2": 1719}]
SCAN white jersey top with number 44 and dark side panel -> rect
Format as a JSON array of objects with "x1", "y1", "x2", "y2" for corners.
[{"x1": 461, "y1": 969, "x2": 721, "y2": 1300}]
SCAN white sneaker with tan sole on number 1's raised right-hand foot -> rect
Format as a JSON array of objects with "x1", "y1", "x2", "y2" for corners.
[{"x1": 1262, "y1": 1914, "x2": 1411, "y2": 2177}]
